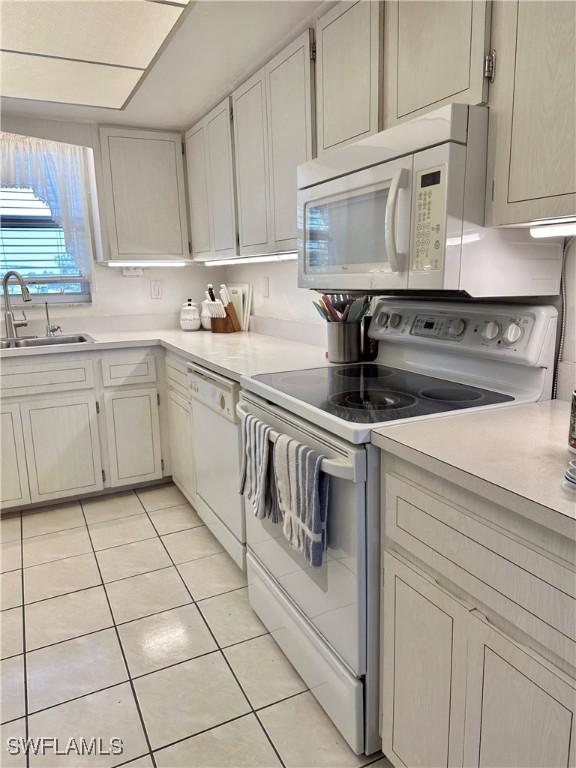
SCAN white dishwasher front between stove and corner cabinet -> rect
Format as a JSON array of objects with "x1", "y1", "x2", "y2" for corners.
[{"x1": 188, "y1": 364, "x2": 246, "y2": 570}]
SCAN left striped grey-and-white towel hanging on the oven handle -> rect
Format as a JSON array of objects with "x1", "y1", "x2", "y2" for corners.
[{"x1": 240, "y1": 414, "x2": 279, "y2": 523}]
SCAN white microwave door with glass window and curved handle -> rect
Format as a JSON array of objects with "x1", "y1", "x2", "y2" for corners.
[{"x1": 298, "y1": 155, "x2": 413, "y2": 291}]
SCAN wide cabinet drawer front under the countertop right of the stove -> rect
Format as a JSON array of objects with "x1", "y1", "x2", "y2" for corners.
[{"x1": 384, "y1": 474, "x2": 576, "y2": 665}]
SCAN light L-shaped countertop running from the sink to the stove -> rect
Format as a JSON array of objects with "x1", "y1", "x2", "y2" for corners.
[{"x1": 0, "y1": 330, "x2": 328, "y2": 381}]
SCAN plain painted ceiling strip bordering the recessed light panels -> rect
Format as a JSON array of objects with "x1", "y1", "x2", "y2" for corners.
[{"x1": 0, "y1": 0, "x2": 334, "y2": 129}]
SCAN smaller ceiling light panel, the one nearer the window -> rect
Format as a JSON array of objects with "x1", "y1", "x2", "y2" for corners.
[{"x1": 0, "y1": 51, "x2": 142, "y2": 109}]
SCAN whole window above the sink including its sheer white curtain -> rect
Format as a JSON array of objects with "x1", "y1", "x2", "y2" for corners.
[{"x1": 0, "y1": 133, "x2": 95, "y2": 303}]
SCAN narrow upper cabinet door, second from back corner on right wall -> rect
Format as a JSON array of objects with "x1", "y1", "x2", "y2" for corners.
[{"x1": 204, "y1": 99, "x2": 237, "y2": 258}]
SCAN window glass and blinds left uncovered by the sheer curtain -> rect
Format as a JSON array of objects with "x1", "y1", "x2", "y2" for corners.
[{"x1": 0, "y1": 187, "x2": 90, "y2": 301}]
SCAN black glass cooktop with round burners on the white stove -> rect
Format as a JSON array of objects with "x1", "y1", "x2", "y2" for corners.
[{"x1": 254, "y1": 363, "x2": 514, "y2": 423}]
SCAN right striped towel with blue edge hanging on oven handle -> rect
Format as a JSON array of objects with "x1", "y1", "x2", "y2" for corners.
[{"x1": 273, "y1": 435, "x2": 329, "y2": 568}]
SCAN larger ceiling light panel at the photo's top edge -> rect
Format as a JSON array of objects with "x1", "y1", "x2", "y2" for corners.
[{"x1": 0, "y1": 0, "x2": 183, "y2": 69}]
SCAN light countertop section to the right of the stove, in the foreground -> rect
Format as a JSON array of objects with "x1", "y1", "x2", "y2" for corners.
[{"x1": 372, "y1": 400, "x2": 576, "y2": 537}]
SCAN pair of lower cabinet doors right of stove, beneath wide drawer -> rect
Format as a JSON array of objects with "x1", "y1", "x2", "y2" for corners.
[{"x1": 381, "y1": 551, "x2": 576, "y2": 768}]
